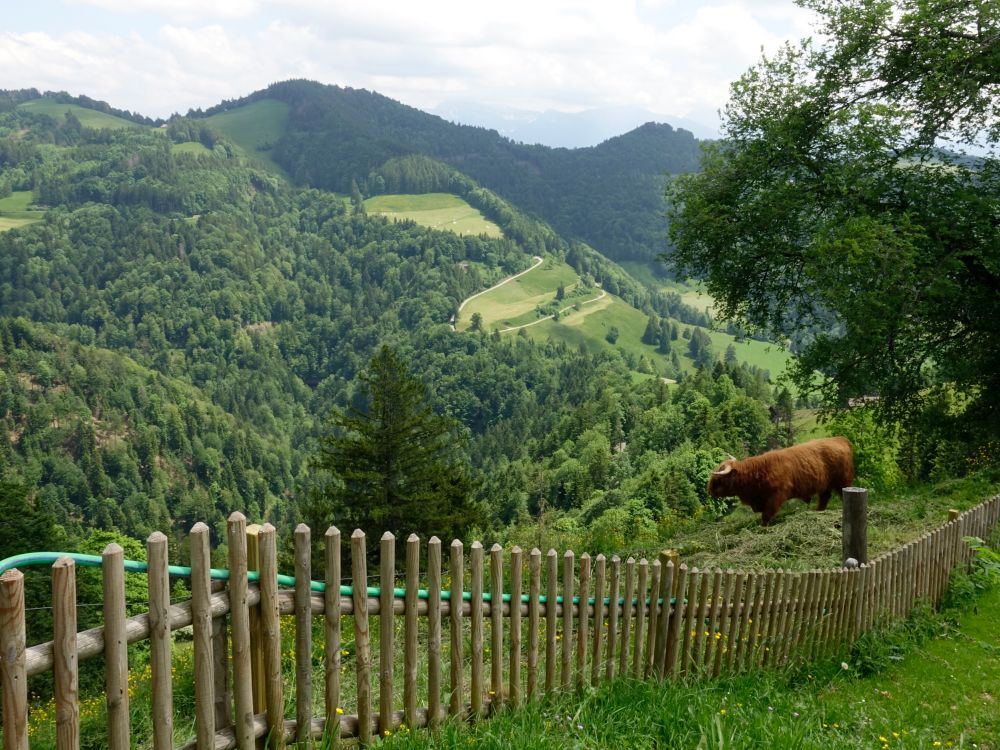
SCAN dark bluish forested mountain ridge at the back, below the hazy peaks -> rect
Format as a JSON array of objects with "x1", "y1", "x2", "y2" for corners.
[{"x1": 192, "y1": 81, "x2": 698, "y2": 261}]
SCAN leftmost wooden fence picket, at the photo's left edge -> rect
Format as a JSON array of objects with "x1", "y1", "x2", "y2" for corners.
[{"x1": 0, "y1": 569, "x2": 28, "y2": 750}]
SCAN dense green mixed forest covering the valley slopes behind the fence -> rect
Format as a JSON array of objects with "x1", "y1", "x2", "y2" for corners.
[{"x1": 0, "y1": 103, "x2": 788, "y2": 580}]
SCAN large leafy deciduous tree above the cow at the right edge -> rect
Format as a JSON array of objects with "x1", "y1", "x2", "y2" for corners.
[{"x1": 667, "y1": 0, "x2": 1000, "y2": 446}]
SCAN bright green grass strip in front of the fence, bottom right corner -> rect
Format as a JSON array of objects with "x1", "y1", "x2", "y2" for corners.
[{"x1": 385, "y1": 586, "x2": 1000, "y2": 750}]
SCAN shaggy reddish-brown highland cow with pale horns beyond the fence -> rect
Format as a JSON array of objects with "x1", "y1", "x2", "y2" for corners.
[{"x1": 708, "y1": 437, "x2": 854, "y2": 526}]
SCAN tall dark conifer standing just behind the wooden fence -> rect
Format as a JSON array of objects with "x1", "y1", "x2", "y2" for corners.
[{"x1": 306, "y1": 346, "x2": 479, "y2": 549}]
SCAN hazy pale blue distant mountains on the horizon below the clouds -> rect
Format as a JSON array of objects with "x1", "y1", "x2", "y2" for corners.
[{"x1": 428, "y1": 101, "x2": 719, "y2": 148}]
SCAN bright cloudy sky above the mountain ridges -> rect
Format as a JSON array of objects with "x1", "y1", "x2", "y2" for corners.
[{"x1": 0, "y1": 0, "x2": 810, "y2": 125}]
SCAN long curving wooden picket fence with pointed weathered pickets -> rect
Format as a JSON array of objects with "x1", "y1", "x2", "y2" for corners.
[{"x1": 0, "y1": 496, "x2": 1000, "y2": 750}]
